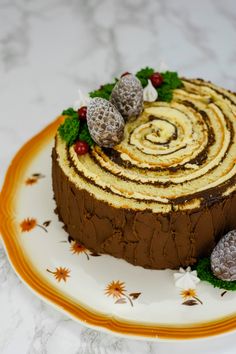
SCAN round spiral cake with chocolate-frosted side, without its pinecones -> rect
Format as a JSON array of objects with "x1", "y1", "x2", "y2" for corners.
[{"x1": 52, "y1": 71, "x2": 236, "y2": 269}]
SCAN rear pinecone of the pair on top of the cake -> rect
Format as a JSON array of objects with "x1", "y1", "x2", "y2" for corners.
[{"x1": 110, "y1": 74, "x2": 143, "y2": 120}]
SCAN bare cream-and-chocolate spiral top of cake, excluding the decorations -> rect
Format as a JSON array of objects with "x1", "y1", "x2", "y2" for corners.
[{"x1": 56, "y1": 79, "x2": 236, "y2": 213}]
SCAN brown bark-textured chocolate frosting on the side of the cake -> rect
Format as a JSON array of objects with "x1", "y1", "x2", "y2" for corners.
[{"x1": 52, "y1": 148, "x2": 236, "y2": 269}]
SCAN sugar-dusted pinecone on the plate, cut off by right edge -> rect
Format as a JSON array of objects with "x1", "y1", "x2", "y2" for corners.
[{"x1": 211, "y1": 230, "x2": 236, "y2": 281}]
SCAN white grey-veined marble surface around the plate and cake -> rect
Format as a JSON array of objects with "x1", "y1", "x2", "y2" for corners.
[{"x1": 0, "y1": 0, "x2": 236, "y2": 354}]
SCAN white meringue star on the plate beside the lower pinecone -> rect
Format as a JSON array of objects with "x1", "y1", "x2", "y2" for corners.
[{"x1": 174, "y1": 267, "x2": 200, "y2": 289}]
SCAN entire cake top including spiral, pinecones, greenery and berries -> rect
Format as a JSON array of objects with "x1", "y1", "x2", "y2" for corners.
[{"x1": 56, "y1": 68, "x2": 236, "y2": 213}]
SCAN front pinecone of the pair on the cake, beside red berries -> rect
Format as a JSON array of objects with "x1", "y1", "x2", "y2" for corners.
[{"x1": 87, "y1": 97, "x2": 125, "y2": 147}]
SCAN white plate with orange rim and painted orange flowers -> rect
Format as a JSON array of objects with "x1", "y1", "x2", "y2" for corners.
[{"x1": 0, "y1": 117, "x2": 236, "y2": 340}]
